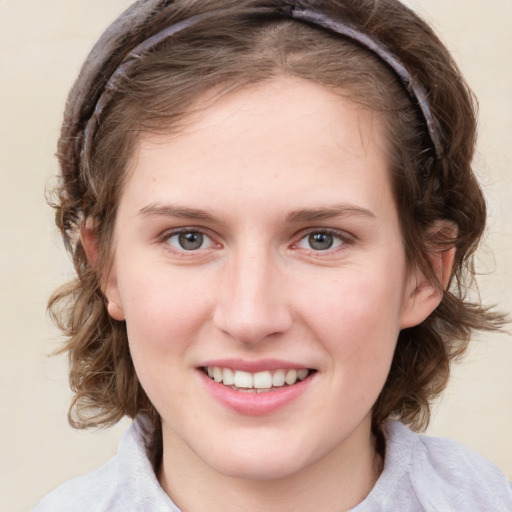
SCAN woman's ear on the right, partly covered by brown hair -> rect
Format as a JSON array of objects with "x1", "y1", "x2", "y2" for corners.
[{"x1": 400, "y1": 221, "x2": 457, "y2": 329}]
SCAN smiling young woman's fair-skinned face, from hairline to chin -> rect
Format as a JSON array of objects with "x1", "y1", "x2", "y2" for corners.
[{"x1": 105, "y1": 77, "x2": 433, "y2": 479}]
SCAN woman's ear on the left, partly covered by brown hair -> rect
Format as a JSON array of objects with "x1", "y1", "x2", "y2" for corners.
[{"x1": 80, "y1": 217, "x2": 125, "y2": 321}]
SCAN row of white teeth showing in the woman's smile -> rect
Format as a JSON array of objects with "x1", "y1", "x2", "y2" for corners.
[{"x1": 205, "y1": 366, "x2": 309, "y2": 393}]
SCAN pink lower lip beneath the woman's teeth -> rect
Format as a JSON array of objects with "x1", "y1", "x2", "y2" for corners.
[{"x1": 198, "y1": 370, "x2": 313, "y2": 416}]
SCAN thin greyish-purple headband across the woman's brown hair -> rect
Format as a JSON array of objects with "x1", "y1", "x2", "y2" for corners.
[{"x1": 82, "y1": 2, "x2": 443, "y2": 162}]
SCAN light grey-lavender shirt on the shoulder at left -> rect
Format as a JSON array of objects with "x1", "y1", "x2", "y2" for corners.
[{"x1": 32, "y1": 418, "x2": 178, "y2": 512}]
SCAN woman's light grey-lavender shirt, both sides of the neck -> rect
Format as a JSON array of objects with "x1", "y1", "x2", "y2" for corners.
[{"x1": 33, "y1": 418, "x2": 512, "y2": 512}]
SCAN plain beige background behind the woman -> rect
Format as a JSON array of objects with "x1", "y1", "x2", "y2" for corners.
[{"x1": 0, "y1": 0, "x2": 512, "y2": 512}]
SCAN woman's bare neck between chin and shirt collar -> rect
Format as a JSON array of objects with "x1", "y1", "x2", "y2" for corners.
[{"x1": 158, "y1": 420, "x2": 382, "y2": 512}]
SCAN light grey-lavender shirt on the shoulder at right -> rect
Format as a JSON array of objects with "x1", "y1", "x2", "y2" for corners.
[{"x1": 368, "y1": 422, "x2": 512, "y2": 512}]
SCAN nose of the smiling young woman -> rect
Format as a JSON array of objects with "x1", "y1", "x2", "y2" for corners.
[{"x1": 213, "y1": 244, "x2": 292, "y2": 344}]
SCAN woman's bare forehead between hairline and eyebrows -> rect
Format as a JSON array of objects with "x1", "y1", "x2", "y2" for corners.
[{"x1": 125, "y1": 76, "x2": 396, "y2": 222}]
